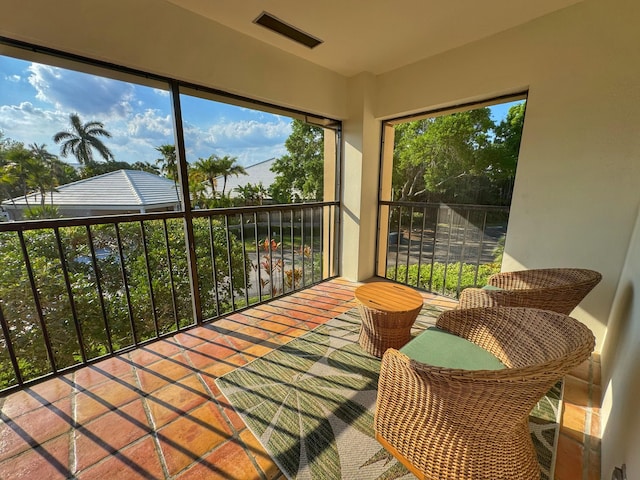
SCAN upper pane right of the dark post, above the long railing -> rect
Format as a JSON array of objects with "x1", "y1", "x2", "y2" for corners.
[{"x1": 180, "y1": 90, "x2": 336, "y2": 208}]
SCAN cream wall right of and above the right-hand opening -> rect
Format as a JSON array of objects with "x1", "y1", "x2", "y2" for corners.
[{"x1": 376, "y1": 0, "x2": 640, "y2": 479}]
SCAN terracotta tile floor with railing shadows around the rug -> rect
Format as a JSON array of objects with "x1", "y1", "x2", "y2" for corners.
[{"x1": 0, "y1": 279, "x2": 600, "y2": 480}]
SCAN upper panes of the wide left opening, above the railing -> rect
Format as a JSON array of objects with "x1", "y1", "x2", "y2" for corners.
[{"x1": 0, "y1": 45, "x2": 337, "y2": 220}]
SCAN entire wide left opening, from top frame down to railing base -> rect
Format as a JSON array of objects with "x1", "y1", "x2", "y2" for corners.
[{"x1": 0, "y1": 37, "x2": 340, "y2": 391}]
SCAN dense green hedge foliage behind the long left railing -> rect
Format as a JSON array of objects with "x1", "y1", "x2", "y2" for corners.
[{"x1": 0, "y1": 219, "x2": 250, "y2": 388}]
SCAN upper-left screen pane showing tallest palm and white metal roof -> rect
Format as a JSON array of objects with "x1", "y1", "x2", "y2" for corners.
[{"x1": 0, "y1": 52, "x2": 176, "y2": 219}]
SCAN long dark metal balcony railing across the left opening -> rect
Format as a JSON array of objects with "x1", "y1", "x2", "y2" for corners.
[{"x1": 0, "y1": 202, "x2": 339, "y2": 393}]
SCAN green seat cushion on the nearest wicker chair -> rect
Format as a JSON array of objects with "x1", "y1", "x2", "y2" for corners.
[{"x1": 400, "y1": 327, "x2": 505, "y2": 370}]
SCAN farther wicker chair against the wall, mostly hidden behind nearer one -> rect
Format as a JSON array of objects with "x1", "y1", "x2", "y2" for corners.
[{"x1": 458, "y1": 268, "x2": 602, "y2": 315}]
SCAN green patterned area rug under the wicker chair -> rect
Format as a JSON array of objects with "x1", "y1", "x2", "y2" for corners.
[{"x1": 217, "y1": 306, "x2": 561, "y2": 480}]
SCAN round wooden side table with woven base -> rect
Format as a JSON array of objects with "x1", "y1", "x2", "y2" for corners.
[{"x1": 355, "y1": 282, "x2": 423, "y2": 357}]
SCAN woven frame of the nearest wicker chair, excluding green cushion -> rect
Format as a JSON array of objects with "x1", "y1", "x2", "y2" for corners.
[{"x1": 375, "y1": 307, "x2": 595, "y2": 480}]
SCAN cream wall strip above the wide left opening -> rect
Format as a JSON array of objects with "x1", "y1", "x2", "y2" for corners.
[{"x1": 0, "y1": 0, "x2": 346, "y2": 122}]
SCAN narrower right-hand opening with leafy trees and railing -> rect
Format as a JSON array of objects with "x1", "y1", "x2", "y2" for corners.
[{"x1": 377, "y1": 95, "x2": 526, "y2": 296}]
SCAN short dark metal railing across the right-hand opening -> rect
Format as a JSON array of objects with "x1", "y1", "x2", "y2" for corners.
[{"x1": 377, "y1": 201, "x2": 509, "y2": 298}]
